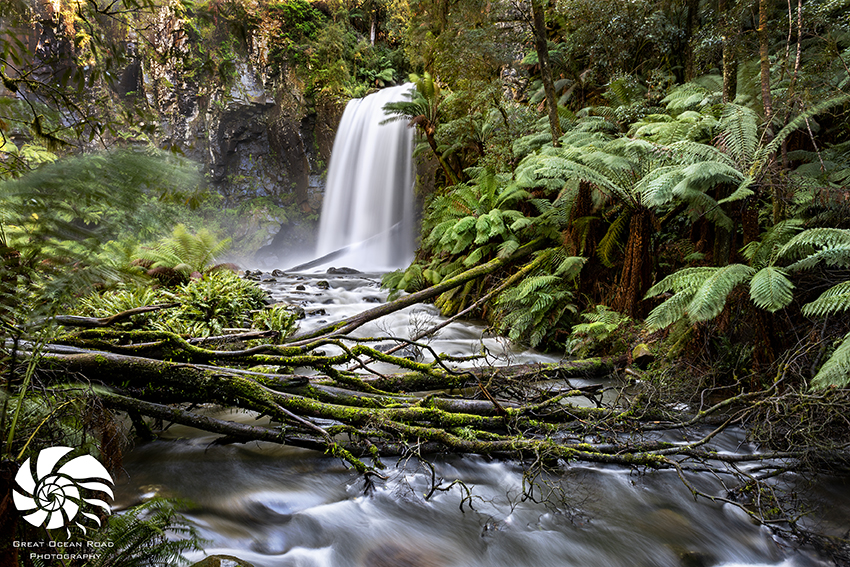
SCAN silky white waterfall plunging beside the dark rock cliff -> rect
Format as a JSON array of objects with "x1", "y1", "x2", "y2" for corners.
[{"x1": 317, "y1": 84, "x2": 414, "y2": 270}]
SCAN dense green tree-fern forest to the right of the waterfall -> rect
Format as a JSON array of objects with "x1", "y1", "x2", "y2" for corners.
[{"x1": 386, "y1": 2, "x2": 850, "y2": 394}]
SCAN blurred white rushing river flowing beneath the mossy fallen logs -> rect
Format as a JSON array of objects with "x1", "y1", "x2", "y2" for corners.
[{"x1": 116, "y1": 276, "x2": 850, "y2": 567}]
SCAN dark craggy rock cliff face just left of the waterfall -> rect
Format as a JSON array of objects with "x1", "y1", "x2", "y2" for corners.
[{"x1": 137, "y1": 11, "x2": 343, "y2": 213}]
